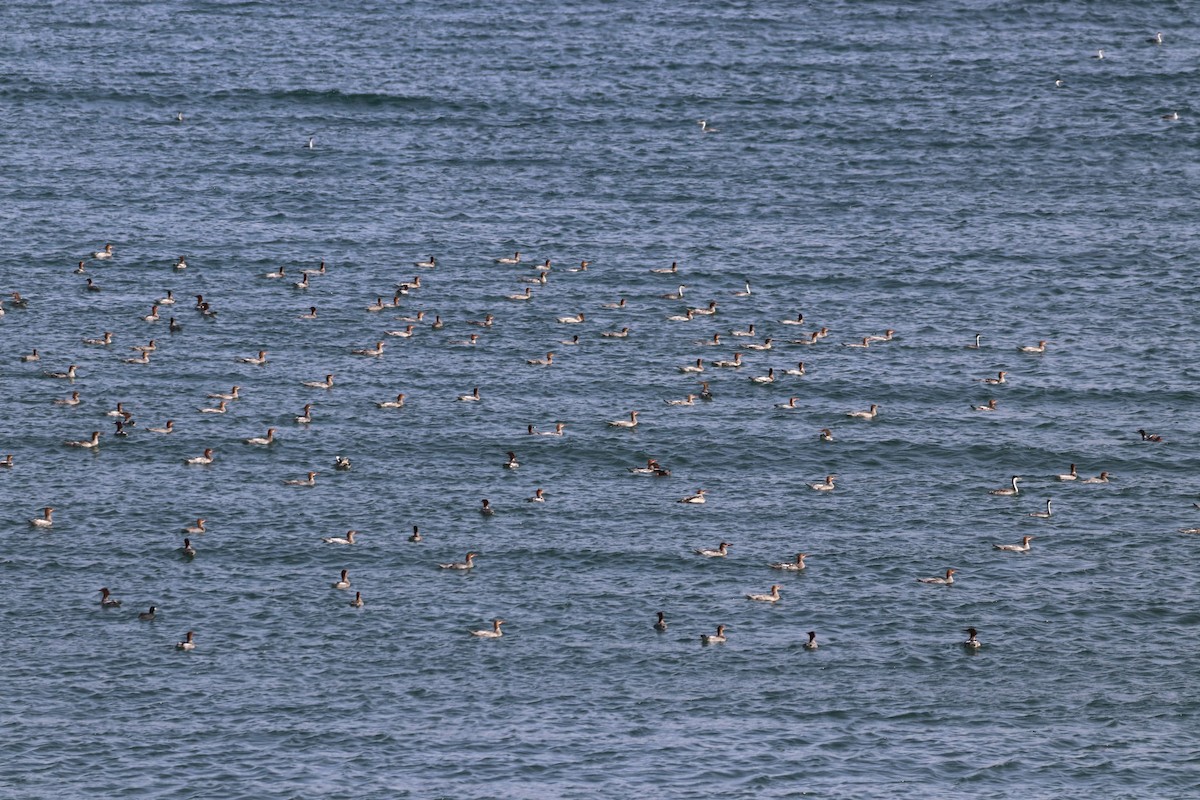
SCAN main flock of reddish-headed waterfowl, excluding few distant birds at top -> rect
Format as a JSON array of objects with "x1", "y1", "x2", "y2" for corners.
[{"x1": 0, "y1": 225, "x2": 1180, "y2": 650}]
